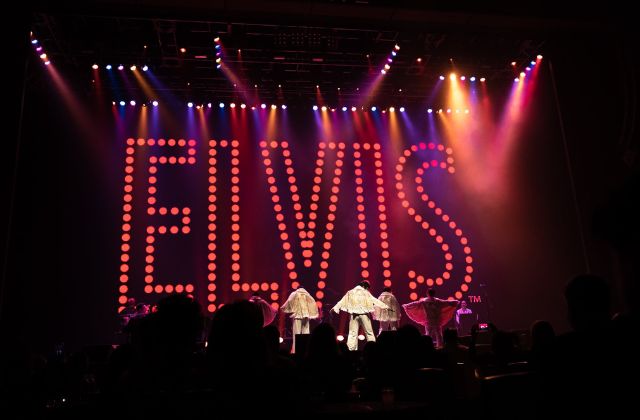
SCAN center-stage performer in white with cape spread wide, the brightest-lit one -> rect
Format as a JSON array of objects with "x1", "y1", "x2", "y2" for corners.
[{"x1": 332, "y1": 280, "x2": 389, "y2": 351}]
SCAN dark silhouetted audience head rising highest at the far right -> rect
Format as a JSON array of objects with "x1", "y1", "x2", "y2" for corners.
[{"x1": 564, "y1": 274, "x2": 611, "y2": 330}]
